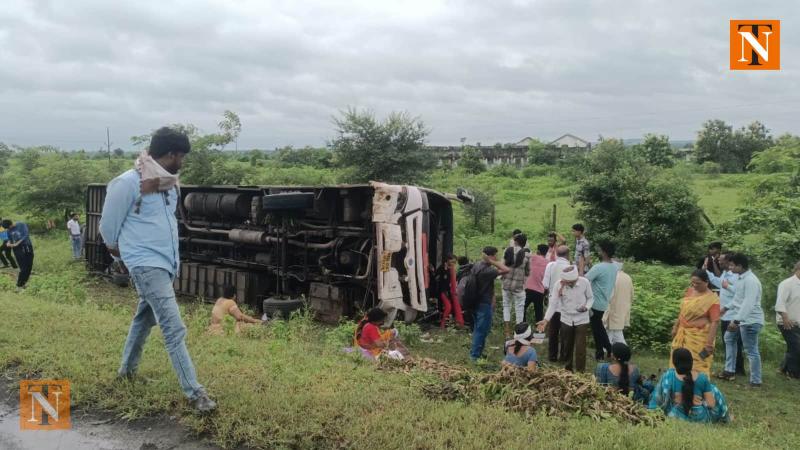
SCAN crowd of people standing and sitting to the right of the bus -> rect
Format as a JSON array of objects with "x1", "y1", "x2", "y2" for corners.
[{"x1": 412, "y1": 230, "x2": 800, "y2": 422}]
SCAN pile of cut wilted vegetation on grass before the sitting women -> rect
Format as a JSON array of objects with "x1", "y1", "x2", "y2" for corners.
[{"x1": 381, "y1": 358, "x2": 663, "y2": 426}]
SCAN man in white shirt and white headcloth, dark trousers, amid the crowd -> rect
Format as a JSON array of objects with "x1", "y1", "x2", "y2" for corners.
[{"x1": 536, "y1": 266, "x2": 594, "y2": 372}]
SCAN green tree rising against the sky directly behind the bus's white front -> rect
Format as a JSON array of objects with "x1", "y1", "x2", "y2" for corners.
[{"x1": 331, "y1": 108, "x2": 436, "y2": 183}]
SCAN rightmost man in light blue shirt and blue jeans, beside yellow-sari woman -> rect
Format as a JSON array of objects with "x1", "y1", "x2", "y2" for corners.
[{"x1": 725, "y1": 253, "x2": 764, "y2": 387}]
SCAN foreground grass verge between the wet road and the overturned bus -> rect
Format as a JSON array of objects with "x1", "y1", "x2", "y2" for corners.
[{"x1": 0, "y1": 236, "x2": 800, "y2": 449}]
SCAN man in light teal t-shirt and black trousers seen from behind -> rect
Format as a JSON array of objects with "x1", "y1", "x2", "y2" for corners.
[{"x1": 586, "y1": 242, "x2": 619, "y2": 360}]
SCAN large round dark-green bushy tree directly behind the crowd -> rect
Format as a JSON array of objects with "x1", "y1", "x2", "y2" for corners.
[{"x1": 574, "y1": 139, "x2": 705, "y2": 263}]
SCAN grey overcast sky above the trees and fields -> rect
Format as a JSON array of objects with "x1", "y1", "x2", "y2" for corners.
[{"x1": 0, "y1": 0, "x2": 800, "y2": 150}]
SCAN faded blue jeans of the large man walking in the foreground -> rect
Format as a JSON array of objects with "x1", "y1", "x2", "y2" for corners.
[{"x1": 119, "y1": 267, "x2": 204, "y2": 400}]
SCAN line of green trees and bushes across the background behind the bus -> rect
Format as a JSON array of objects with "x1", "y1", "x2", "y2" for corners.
[{"x1": 0, "y1": 109, "x2": 800, "y2": 268}]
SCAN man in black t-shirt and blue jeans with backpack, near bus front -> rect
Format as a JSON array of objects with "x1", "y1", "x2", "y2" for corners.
[{"x1": 469, "y1": 247, "x2": 509, "y2": 361}]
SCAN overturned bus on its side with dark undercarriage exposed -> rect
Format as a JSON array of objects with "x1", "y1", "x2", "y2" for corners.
[{"x1": 85, "y1": 182, "x2": 471, "y2": 322}]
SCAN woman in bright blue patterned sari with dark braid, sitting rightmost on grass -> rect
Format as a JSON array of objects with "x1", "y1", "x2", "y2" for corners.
[{"x1": 648, "y1": 348, "x2": 731, "y2": 423}]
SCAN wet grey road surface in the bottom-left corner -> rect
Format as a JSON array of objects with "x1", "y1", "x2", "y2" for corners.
[{"x1": 0, "y1": 380, "x2": 219, "y2": 450}]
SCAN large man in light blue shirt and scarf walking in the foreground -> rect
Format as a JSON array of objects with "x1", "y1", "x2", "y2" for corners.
[{"x1": 100, "y1": 127, "x2": 217, "y2": 412}]
